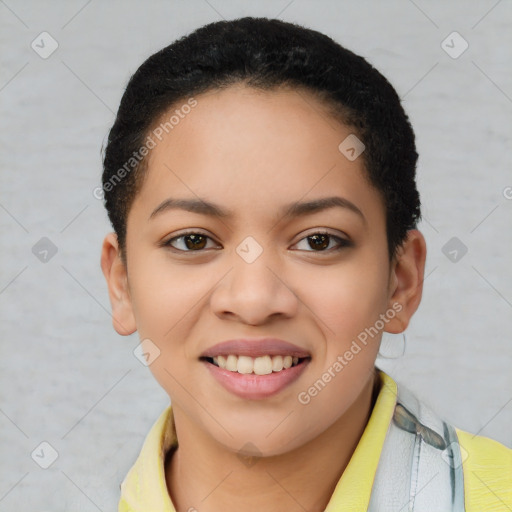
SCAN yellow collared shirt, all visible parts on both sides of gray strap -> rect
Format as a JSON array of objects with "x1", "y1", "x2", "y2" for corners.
[{"x1": 118, "y1": 370, "x2": 512, "y2": 512}]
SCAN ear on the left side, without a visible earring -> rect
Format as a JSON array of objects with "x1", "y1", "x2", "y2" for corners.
[{"x1": 101, "y1": 232, "x2": 137, "y2": 336}]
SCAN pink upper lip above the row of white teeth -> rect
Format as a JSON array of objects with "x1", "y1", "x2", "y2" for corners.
[{"x1": 200, "y1": 338, "x2": 311, "y2": 358}]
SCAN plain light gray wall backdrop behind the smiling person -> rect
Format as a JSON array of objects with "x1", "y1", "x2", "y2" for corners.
[{"x1": 0, "y1": 0, "x2": 512, "y2": 511}]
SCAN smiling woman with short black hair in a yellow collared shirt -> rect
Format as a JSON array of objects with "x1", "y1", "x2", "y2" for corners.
[{"x1": 101, "y1": 18, "x2": 512, "y2": 512}]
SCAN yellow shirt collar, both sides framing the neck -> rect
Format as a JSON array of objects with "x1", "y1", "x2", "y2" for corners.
[{"x1": 119, "y1": 368, "x2": 397, "y2": 512}]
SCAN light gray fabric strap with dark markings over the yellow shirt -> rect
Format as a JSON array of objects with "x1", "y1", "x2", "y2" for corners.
[{"x1": 368, "y1": 378, "x2": 465, "y2": 512}]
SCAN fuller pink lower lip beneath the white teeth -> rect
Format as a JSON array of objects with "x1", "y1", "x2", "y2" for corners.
[{"x1": 204, "y1": 359, "x2": 310, "y2": 400}]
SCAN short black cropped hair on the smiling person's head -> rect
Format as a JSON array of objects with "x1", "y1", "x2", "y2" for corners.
[{"x1": 102, "y1": 17, "x2": 421, "y2": 264}]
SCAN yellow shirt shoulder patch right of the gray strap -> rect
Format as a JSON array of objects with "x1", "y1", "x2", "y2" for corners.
[{"x1": 455, "y1": 428, "x2": 512, "y2": 512}]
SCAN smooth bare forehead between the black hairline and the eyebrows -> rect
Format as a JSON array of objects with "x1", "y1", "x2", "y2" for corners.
[{"x1": 128, "y1": 85, "x2": 383, "y2": 226}]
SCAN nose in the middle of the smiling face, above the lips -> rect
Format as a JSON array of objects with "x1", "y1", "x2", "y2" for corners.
[{"x1": 210, "y1": 247, "x2": 299, "y2": 325}]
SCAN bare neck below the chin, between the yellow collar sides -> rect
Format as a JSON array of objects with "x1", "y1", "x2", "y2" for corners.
[{"x1": 165, "y1": 372, "x2": 380, "y2": 512}]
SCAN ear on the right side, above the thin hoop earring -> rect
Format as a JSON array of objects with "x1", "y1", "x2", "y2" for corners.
[{"x1": 384, "y1": 229, "x2": 427, "y2": 334}]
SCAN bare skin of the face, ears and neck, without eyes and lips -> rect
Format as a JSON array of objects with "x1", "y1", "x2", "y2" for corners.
[{"x1": 101, "y1": 85, "x2": 426, "y2": 512}]
